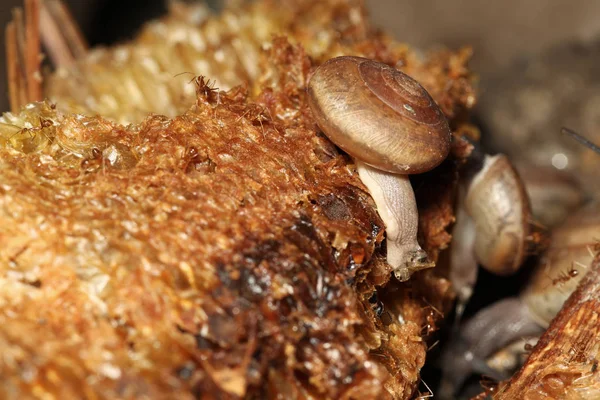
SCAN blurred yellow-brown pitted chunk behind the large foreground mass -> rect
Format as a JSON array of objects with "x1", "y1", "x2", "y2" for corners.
[{"x1": 42, "y1": 0, "x2": 475, "y2": 123}]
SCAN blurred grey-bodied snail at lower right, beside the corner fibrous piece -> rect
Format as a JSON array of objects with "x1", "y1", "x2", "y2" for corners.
[{"x1": 444, "y1": 202, "x2": 600, "y2": 393}]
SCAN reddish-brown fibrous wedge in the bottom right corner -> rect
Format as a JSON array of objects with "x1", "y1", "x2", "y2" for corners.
[{"x1": 486, "y1": 256, "x2": 600, "y2": 400}]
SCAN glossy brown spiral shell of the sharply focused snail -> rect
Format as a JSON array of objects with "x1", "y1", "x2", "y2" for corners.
[{"x1": 308, "y1": 56, "x2": 451, "y2": 174}]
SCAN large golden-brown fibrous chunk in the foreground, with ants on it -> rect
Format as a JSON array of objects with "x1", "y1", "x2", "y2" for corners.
[{"x1": 0, "y1": 72, "x2": 394, "y2": 398}]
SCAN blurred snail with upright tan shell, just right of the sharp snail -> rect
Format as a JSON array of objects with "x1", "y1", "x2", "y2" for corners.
[{"x1": 450, "y1": 151, "x2": 531, "y2": 315}]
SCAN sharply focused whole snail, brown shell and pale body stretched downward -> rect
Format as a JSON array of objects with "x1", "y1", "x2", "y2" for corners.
[{"x1": 308, "y1": 56, "x2": 451, "y2": 281}]
